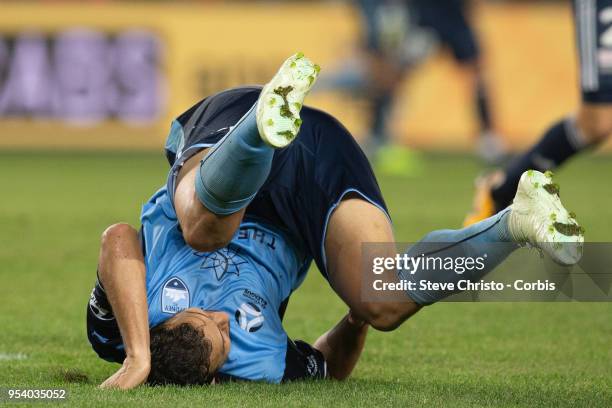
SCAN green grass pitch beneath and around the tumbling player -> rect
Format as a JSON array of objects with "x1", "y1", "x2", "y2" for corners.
[{"x1": 0, "y1": 152, "x2": 612, "y2": 407}]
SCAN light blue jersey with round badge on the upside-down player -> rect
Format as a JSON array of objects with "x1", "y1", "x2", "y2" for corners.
[{"x1": 141, "y1": 187, "x2": 310, "y2": 383}]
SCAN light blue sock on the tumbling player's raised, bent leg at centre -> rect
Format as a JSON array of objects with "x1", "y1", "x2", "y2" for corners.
[{"x1": 195, "y1": 104, "x2": 274, "y2": 215}]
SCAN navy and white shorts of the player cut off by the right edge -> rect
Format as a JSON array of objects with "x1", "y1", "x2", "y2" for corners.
[{"x1": 574, "y1": 0, "x2": 612, "y2": 103}]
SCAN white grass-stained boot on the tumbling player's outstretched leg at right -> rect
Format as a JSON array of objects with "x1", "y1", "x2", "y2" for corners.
[{"x1": 508, "y1": 170, "x2": 584, "y2": 266}]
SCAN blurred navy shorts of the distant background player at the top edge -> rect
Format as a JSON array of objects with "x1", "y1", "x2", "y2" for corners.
[{"x1": 412, "y1": 0, "x2": 480, "y2": 63}]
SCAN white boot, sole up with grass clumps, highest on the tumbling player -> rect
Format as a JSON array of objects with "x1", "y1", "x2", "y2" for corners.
[{"x1": 257, "y1": 52, "x2": 320, "y2": 148}]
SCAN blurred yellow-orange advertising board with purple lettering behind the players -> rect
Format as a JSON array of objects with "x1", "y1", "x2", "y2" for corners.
[{"x1": 0, "y1": 0, "x2": 604, "y2": 155}]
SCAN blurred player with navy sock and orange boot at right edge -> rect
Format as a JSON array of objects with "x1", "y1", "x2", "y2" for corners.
[{"x1": 464, "y1": 0, "x2": 612, "y2": 225}]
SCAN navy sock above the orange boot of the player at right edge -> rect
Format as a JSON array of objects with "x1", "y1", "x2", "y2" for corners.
[{"x1": 491, "y1": 117, "x2": 588, "y2": 210}]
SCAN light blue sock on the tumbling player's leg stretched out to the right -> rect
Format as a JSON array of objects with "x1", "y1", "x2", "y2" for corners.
[{"x1": 398, "y1": 208, "x2": 519, "y2": 305}]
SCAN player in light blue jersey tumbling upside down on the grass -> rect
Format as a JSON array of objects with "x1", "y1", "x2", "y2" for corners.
[{"x1": 88, "y1": 54, "x2": 583, "y2": 388}]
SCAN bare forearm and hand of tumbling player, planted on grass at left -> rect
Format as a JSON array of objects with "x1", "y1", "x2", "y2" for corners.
[{"x1": 98, "y1": 224, "x2": 151, "y2": 389}]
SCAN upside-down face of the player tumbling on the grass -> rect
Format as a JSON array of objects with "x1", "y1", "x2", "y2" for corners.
[{"x1": 167, "y1": 307, "x2": 230, "y2": 372}]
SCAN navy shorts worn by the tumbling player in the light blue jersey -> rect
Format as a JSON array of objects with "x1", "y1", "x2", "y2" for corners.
[{"x1": 166, "y1": 87, "x2": 388, "y2": 277}]
